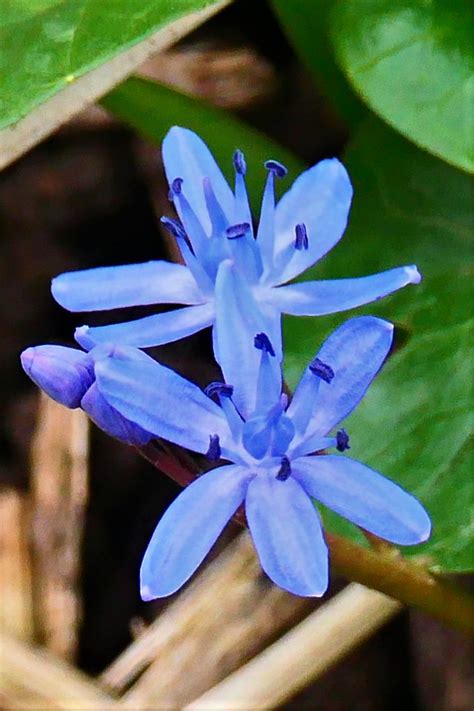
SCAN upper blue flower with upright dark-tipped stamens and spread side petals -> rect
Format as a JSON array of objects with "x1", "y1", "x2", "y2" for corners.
[{"x1": 52, "y1": 126, "x2": 421, "y2": 414}]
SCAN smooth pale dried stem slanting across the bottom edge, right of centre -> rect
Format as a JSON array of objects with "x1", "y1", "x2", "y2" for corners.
[{"x1": 184, "y1": 583, "x2": 401, "y2": 711}]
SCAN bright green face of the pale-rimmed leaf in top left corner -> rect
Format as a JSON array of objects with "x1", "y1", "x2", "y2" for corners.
[{"x1": 0, "y1": 0, "x2": 226, "y2": 128}]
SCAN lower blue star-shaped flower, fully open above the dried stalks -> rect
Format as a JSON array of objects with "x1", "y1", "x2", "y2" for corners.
[{"x1": 95, "y1": 317, "x2": 430, "y2": 600}]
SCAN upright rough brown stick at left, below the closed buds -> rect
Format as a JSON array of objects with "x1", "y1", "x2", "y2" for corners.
[{"x1": 31, "y1": 395, "x2": 88, "y2": 659}]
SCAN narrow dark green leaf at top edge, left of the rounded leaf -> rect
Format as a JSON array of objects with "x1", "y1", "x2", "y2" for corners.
[{"x1": 271, "y1": 0, "x2": 366, "y2": 126}]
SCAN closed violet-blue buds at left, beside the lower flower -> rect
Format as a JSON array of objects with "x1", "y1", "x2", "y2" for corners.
[{"x1": 21, "y1": 345, "x2": 153, "y2": 445}]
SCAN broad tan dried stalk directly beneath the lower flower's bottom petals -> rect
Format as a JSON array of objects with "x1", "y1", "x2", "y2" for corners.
[{"x1": 101, "y1": 532, "x2": 315, "y2": 709}]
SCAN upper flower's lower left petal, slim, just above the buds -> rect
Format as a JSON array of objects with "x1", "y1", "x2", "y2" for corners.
[{"x1": 74, "y1": 304, "x2": 214, "y2": 350}]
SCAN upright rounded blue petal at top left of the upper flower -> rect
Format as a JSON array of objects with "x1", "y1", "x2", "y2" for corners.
[{"x1": 162, "y1": 126, "x2": 234, "y2": 231}]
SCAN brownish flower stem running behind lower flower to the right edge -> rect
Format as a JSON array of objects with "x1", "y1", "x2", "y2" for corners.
[{"x1": 137, "y1": 441, "x2": 474, "y2": 635}]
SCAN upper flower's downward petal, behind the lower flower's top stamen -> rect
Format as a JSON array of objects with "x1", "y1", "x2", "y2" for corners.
[{"x1": 214, "y1": 260, "x2": 281, "y2": 418}]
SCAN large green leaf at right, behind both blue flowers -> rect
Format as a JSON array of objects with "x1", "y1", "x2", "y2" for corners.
[{"x1": 285, "y1": 121, "x2": 474, "y2": 572}]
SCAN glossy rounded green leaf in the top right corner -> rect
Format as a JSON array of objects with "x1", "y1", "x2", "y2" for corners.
[{"x1": 332, "y1": 0, "x2": 474, "y2": 171}]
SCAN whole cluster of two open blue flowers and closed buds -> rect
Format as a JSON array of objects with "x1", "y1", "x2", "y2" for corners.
[{"x1": 21, "y1": 127, "x2": 430, "y2": 600}]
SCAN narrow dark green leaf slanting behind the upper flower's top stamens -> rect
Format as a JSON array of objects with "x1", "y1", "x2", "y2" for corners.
[{"x1": 101, "y1": 77, "x2": 304, "y2": 210}]
